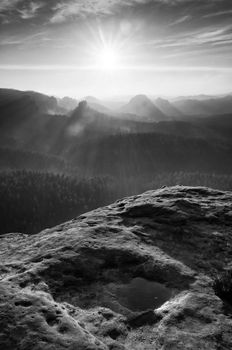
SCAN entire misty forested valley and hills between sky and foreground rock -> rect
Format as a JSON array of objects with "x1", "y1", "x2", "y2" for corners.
[{"x1": 0, "y1": 89, "x2": 232, "y2": 233}]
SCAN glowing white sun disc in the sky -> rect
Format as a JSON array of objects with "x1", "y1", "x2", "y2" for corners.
[{"x1": 97, "y1": 47, "x2": 120, "y2": 70}]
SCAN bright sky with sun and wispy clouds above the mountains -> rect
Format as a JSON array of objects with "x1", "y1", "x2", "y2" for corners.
[{"x1": 0, "y1": 0, "x2": 232, "y2": 97}]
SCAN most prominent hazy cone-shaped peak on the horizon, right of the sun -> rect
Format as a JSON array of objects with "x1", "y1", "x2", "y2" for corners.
[{"x1": 120, "y1": 95, "x2": 168, "y2": 122}]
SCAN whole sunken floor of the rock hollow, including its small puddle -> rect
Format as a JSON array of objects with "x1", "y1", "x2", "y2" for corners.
[{"x1": 52, "y1": 277, "x2": 177, "y2": 316}]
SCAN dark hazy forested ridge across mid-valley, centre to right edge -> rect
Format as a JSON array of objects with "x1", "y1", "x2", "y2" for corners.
[{"x1": 65, "y1": 133, "x2": 232, "y2": 179}]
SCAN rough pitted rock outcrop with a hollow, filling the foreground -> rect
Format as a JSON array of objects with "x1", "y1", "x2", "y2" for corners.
[{"x1": 0, "y1": 186, "x2": 232, "y2": 350}]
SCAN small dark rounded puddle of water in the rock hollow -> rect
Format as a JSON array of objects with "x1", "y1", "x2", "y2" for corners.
[{"x1": 114, "y1": 277, "x2": 176, "y2": 311}]
